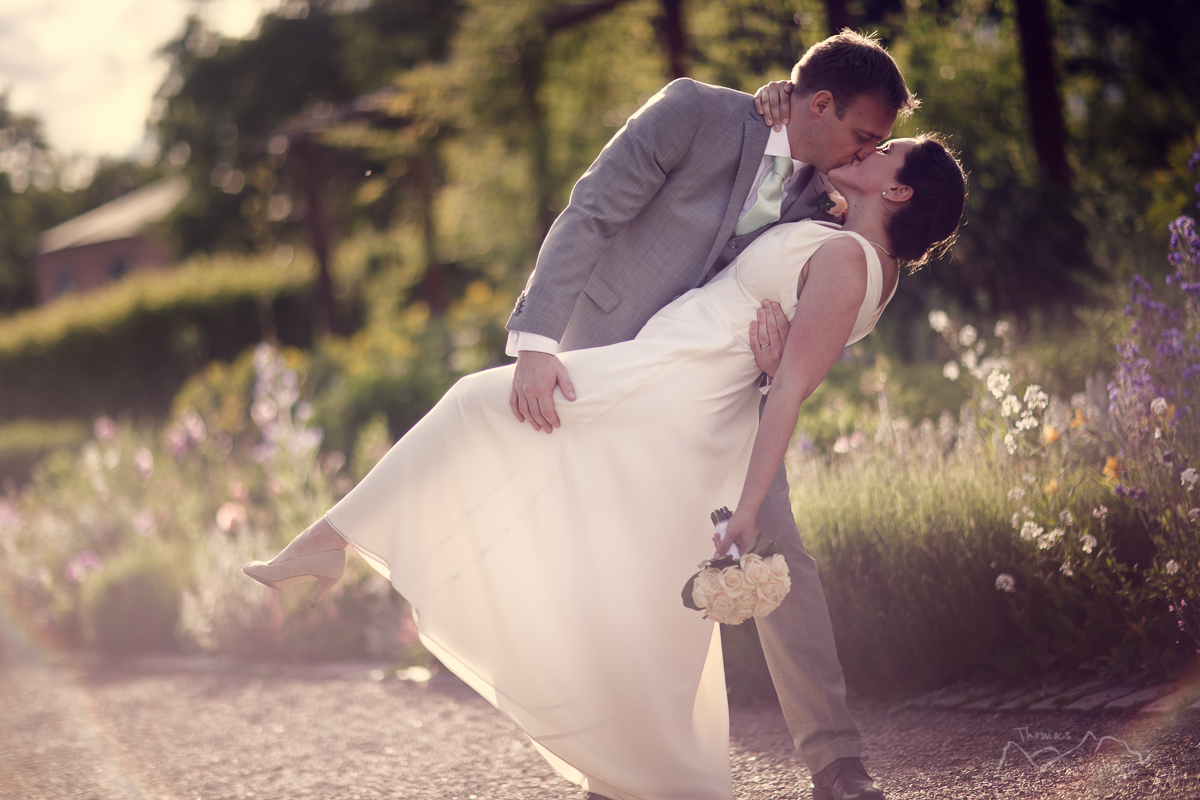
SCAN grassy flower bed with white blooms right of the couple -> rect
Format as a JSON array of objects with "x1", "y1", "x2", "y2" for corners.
[{"x1": 788, "y1": 281, "x2": 1200, "y2": 692}]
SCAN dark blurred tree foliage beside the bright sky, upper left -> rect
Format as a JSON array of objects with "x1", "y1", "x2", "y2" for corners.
[{"x1": 157, "y1": 0, "x2": 458, "y2": 253}]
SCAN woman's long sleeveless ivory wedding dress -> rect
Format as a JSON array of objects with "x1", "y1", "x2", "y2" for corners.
[{"x1": 328, "y1": 222, "x2": 894, "y2": 800}]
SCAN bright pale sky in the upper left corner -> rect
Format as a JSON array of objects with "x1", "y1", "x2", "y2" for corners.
[{"x1": 0, "y1": 0, "x2": 280, "y2": 158}]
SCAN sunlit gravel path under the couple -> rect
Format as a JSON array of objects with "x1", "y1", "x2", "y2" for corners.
[{"x1": 0, "y1": 628, "x2": 1200, "y2": 800}]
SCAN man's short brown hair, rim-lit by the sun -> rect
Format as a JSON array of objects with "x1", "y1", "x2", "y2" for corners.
[{"x1": 792, "y1": 28, "x2": 920, "y2": 119}]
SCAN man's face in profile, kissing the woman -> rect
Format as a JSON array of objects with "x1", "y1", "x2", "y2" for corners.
[{"x1": 788, "y1": 91, "x2": 896, "y2": 173}]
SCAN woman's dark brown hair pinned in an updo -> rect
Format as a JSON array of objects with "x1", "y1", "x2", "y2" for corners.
[{"x1": 888, "y1": 133, "x2": 967, "y2": 272}]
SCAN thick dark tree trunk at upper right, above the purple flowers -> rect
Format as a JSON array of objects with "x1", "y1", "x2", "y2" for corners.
[{"x1": 1016, "y1": 0, "x2": 1070, "y2": 191}]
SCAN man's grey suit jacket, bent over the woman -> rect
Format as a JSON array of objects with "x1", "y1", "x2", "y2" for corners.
[{"x1": 508, "y1": 78, "x2": 833, "y2": 350}]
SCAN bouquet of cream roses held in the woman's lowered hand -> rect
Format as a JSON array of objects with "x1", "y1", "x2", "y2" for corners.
[{"x1": 683, "y1": 507, "x2": 792, "y2": 625}]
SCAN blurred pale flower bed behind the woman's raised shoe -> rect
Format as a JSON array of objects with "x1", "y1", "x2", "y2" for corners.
[{"x1": 0, "y1": 345, "x2": 429, "y2": 658}]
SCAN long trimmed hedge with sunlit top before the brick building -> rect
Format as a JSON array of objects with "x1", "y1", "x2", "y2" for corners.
[{"x1": 0, "y1": 258, "x2": 313, "y2": 420}]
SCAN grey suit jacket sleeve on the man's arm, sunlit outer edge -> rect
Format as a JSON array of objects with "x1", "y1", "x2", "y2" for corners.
[{"x1": 506, "y1": 78, "x2": 703, "y2": 339}]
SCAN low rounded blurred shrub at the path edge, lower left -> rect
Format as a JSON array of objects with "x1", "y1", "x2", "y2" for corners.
[{"x1": 79, "y1": 545, "x2": 187, "y2": 655}]
